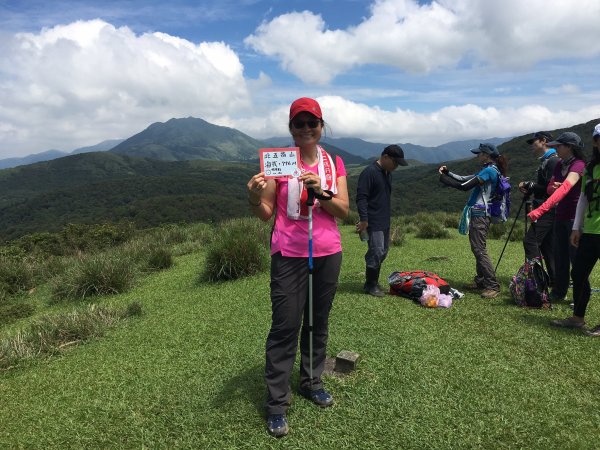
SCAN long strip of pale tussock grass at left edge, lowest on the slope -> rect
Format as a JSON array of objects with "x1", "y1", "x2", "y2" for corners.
[{"x1": 0, "y1": 303, "x2": 141, "y2": 369}]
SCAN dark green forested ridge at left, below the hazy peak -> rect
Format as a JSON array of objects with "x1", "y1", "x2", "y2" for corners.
[{"x1": 0, "y1": 152, "x2": 258, "y2": 241}]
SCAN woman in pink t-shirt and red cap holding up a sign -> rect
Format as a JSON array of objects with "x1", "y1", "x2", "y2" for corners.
[{"x1": 247, "y1": 97, "x2": 349, "y2": 437}]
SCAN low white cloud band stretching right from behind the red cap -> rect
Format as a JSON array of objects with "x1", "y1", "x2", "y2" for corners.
[{"x1": 237, "y1": 96, "x2": 600, "y2": 146}]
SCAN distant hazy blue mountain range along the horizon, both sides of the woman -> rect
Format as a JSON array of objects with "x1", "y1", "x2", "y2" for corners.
[{"x1": 0, "y1": 117, "x2": 509, "y2": 169}]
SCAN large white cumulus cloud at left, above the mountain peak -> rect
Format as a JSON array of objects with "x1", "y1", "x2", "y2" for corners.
[{"x1": 0, "y1": 20, "x2": 252, "y2": 153}]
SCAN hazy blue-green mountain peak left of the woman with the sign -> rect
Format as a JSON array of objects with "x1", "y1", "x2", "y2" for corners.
[{"x1": 110, "y1": 117, "x2": 264, "y2": 161}]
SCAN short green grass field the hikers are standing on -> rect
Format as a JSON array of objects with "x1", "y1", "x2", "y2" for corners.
[{"x1": 0, "y1": 226, "x2": 600, "y2": 449}]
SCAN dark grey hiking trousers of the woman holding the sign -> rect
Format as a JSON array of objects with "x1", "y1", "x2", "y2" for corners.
[{"x1": 265, "y1": 252, "x2": 342, "y2": 415}]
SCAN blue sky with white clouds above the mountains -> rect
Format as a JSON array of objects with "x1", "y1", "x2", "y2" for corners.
[{"x1": 0, "y1": 0, "x2": 600, "y2": 158}]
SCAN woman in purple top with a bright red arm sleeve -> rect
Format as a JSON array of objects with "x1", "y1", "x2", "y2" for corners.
[{"x1": 528, "y1": 131, "x2": 585, "y2": 301}]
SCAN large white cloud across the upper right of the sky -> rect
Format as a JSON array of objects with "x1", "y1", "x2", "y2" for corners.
[{"x1": 245, "y1": 0, "x2": 600, "y2": 84}]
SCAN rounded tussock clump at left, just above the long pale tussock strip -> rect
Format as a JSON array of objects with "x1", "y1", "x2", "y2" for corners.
[{"x1": 51, "y1": 251, "x2": 136, "y2": 301}]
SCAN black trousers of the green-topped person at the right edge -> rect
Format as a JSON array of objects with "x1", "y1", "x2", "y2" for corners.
[{"x1": 573, "y1": 234, "x2": 600, "y2": 318}]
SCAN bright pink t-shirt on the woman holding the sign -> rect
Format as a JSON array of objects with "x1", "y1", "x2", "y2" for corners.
[{"x1": 271, "y1": 156, "x2": 346, "y2": 258}]
